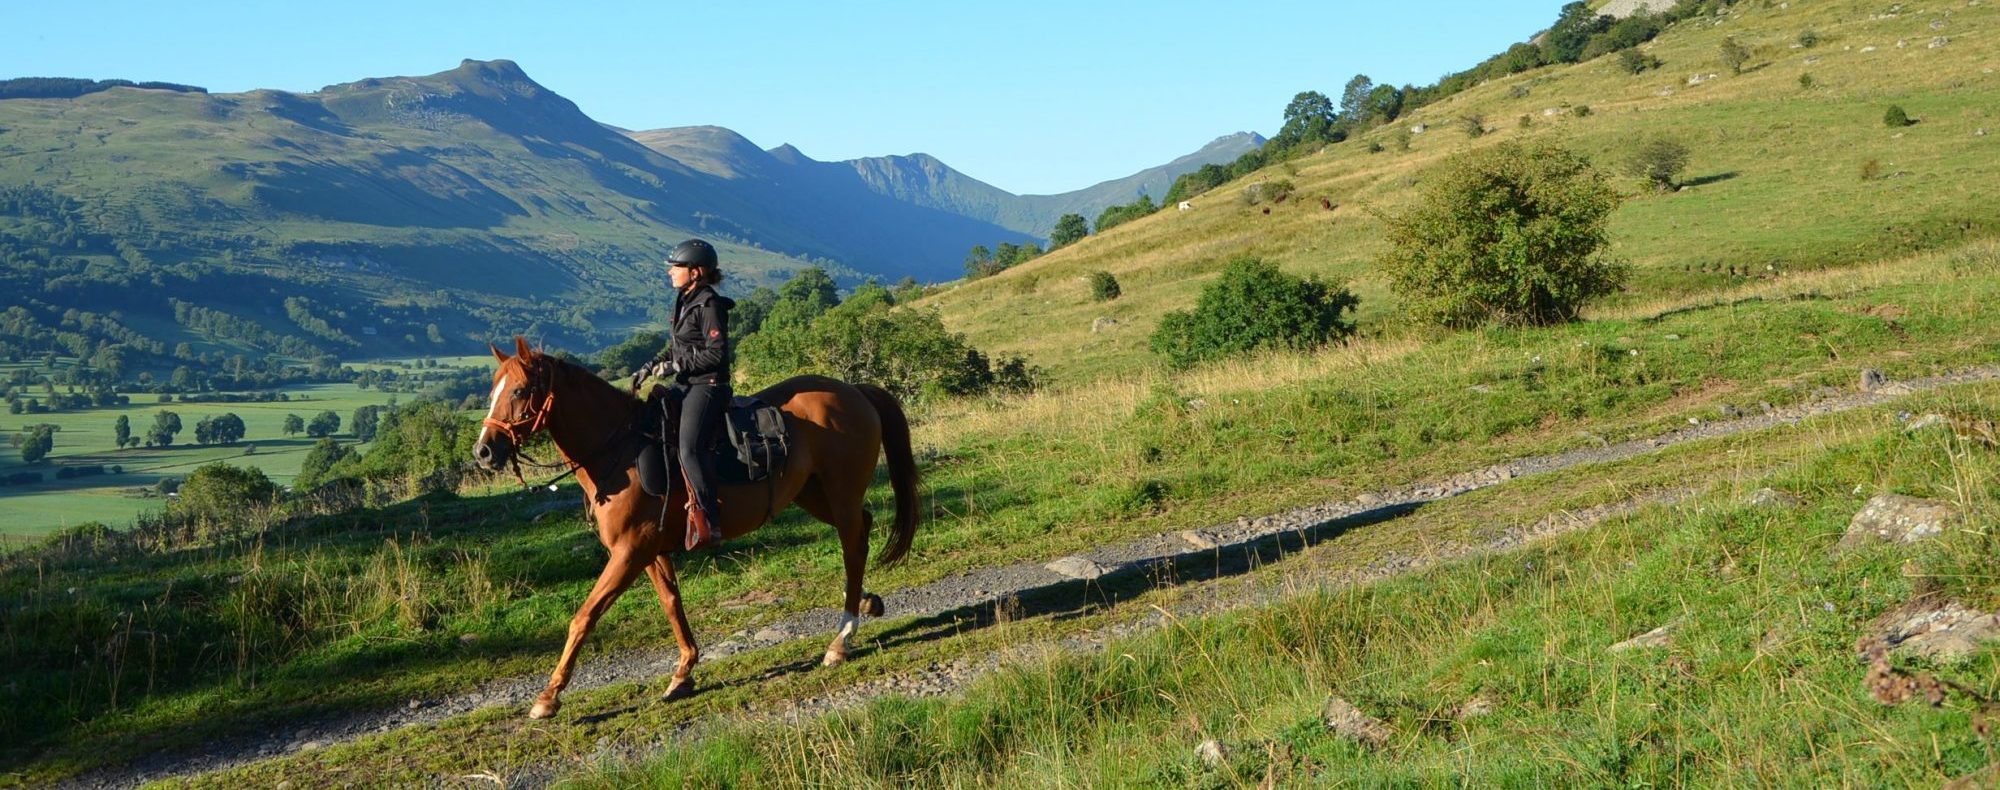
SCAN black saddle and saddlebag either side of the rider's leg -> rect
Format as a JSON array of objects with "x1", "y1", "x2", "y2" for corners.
[{"x1": 638, "y1": 390, "x2": 792, "y2": 496}]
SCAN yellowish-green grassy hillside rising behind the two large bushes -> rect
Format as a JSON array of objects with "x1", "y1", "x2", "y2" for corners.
[{"x1": 928, "y1": 2, "x2": 2000, "y2": 382}]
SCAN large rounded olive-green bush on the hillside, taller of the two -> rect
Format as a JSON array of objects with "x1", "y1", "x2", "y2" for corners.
[{"x1": 1382, "y1": 142, "x2": 1624, "y2": 326}]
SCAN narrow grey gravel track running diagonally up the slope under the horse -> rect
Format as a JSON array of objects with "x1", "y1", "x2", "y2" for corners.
[{"x1": 66, "y1": 366, "x2": 2000, "y2": 788}]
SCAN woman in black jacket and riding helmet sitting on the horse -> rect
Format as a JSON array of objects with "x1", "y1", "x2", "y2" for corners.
[{"x1": 640, "y1": 238, "x2": 736, "y2": 550}]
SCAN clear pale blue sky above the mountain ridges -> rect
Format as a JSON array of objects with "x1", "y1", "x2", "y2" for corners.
[{"x1": 0, "y1": 0, "x2": 1562, "y2": 194}]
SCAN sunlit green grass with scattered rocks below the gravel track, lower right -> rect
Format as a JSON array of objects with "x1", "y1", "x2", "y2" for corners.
[{"x1": 576, "y1": 386, "x2": 2000, "y2": 786}]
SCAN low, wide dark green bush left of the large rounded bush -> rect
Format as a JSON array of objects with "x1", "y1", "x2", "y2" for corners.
[{"x1": 1150, "y1": 258, "x2": 1360, "y2": 370}]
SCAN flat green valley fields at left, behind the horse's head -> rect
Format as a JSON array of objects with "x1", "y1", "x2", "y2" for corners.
[{"x1": 0, "y1": 384, "x2": 402, "y2": 540}]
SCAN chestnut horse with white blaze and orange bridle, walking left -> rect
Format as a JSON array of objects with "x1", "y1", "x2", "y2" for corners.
[{"x1": 474, "y1": 338, "x2": 918, "y2": 718}]
